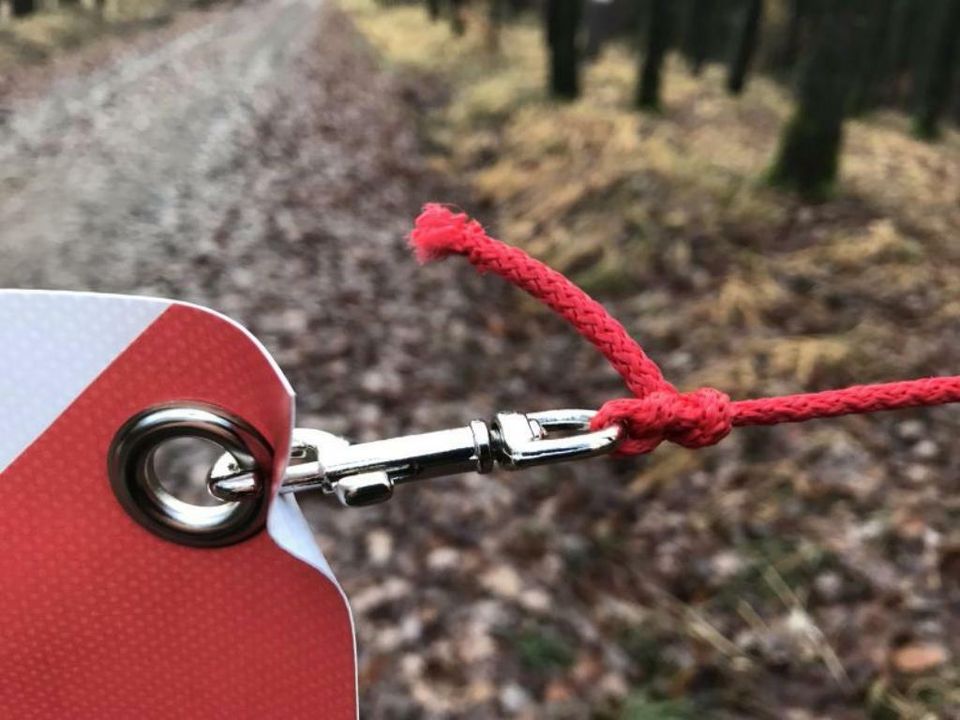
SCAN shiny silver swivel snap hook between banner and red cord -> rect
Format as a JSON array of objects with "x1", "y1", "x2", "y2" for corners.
[{"x1": 208, "y1": 410, "x2": 622, "y2": 507}]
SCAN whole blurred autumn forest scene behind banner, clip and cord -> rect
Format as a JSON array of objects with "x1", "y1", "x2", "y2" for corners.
[{"x1": 0, "y1": 0, "x2": 960, "y2": 720}]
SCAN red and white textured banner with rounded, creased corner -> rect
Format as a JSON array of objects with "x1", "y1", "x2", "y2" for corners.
[{"x1": 0, "y1": 291, "x2": 357, "y2": 720}]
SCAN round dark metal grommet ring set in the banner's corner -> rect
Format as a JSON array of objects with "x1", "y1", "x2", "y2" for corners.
[{"x1": 109, "y1": 405, "x2": 271, "y2": 547}]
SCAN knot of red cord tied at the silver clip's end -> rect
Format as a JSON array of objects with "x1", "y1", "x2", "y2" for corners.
[{"x1": 591, "y1": 388, "x2": 733, "y2": 455}]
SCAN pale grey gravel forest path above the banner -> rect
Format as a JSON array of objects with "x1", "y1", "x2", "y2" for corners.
[{"x1": 0, "y1": 0, "x2": 320, "y2": 290}]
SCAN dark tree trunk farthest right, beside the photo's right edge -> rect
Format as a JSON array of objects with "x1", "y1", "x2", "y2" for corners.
[{"x1": 913, "y1": 0, "x2": 960, "y2": 140}]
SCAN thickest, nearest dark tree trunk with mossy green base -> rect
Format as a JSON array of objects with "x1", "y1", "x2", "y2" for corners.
[{"x1": 770, "y1": 0, "x2": 858, "y2": 198}]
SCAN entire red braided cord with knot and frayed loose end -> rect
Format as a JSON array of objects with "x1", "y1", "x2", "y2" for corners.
[{"x1": 410, "y1": 204, "x2": 960, "y2": 455}]
